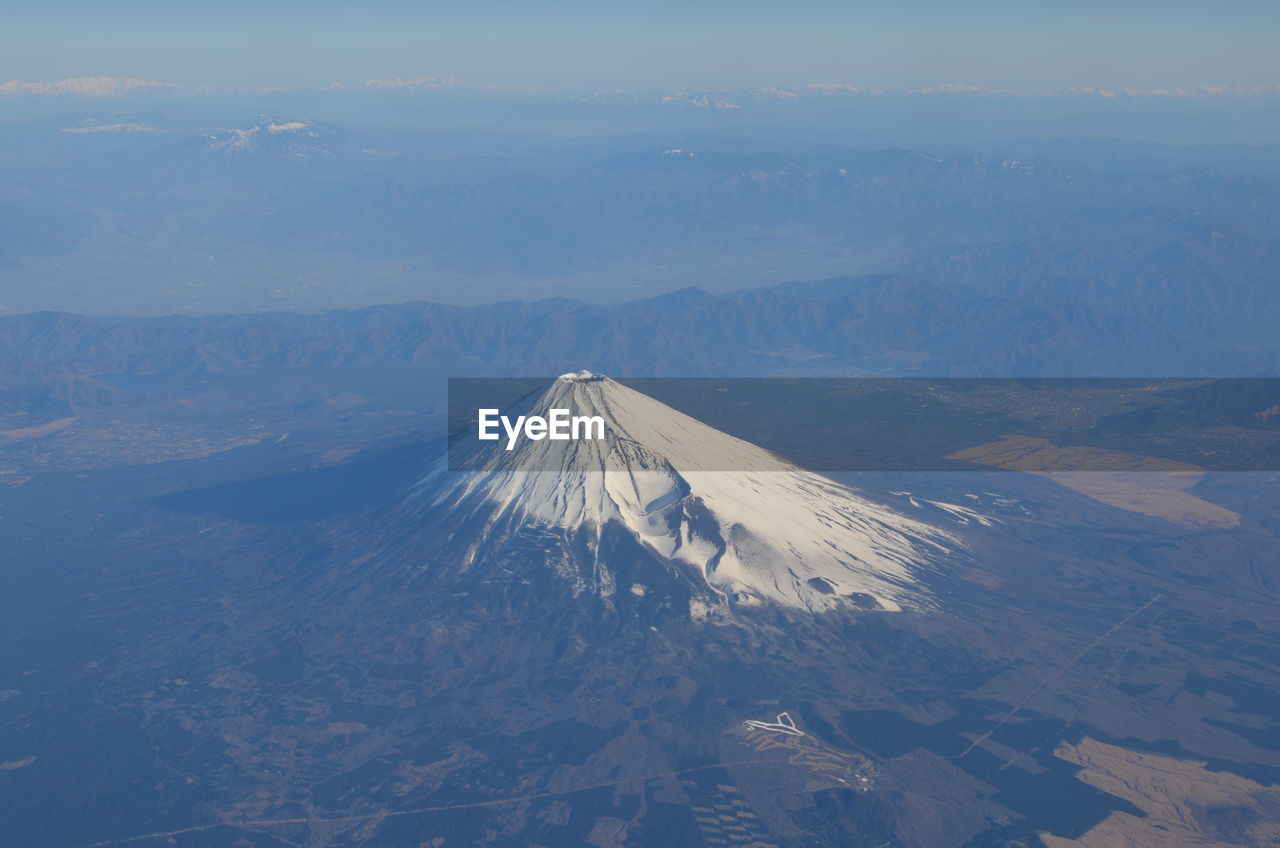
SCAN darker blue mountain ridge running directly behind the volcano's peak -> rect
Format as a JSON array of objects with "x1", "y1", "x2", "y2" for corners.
[{"x1": 0, "y1": 275, "x2": 1280, "y2": 386}]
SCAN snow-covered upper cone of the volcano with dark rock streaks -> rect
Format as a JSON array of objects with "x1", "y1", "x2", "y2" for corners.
[{"x1": 413, "y1": 371, "x2": 956, "y2": 611}]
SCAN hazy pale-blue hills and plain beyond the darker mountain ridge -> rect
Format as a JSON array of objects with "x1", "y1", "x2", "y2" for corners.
[{"x1": 0, "y1": 122, "x2": 1280, "y2": 315}]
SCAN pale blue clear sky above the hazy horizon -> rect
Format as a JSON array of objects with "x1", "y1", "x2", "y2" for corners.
[{"x1": 0, "y1": 0, "x2": 1280, "y2": 91}]
